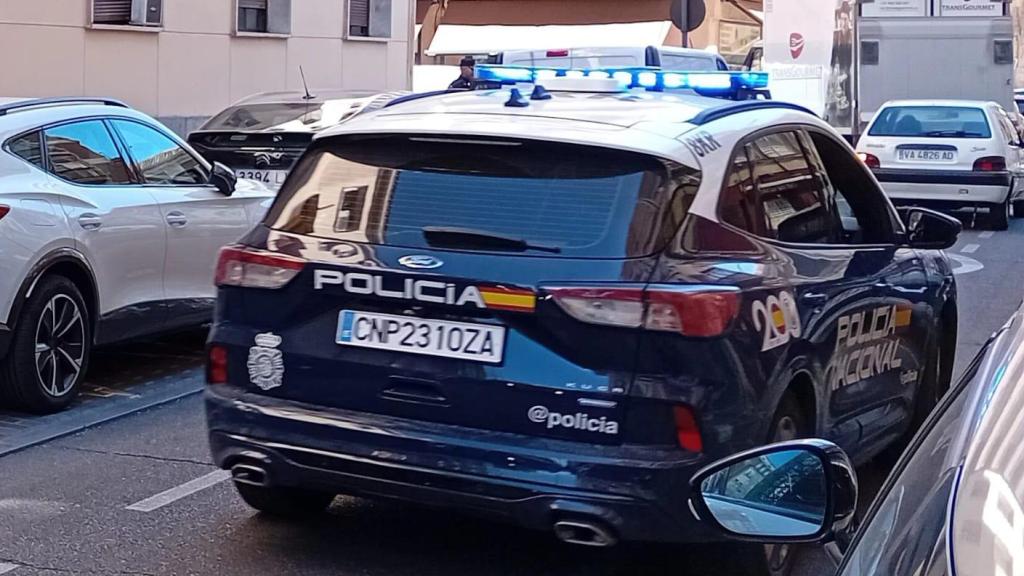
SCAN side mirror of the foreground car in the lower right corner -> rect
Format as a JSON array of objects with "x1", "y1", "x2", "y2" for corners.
[{"x1": 690, "y1": 440, "x2": 857, "y2": 543}]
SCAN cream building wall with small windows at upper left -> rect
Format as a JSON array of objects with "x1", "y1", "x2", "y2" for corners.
[{"x1": 0, "y1": 0, "x2": 415, "y2": 133}]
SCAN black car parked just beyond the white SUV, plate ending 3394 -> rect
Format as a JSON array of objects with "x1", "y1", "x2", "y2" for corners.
[{"x1": 187, "y1": 90, "x2": 404, "y2": 190}]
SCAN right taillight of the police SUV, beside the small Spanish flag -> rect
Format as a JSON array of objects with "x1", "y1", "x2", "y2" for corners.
[{"x1": 547, "y1": 286, "x2": 739, "y2": 336}]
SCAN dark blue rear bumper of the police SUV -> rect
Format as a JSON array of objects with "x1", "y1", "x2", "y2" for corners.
[{"x1": 206, "y1": 386, "x2": 721, "y2": 542}]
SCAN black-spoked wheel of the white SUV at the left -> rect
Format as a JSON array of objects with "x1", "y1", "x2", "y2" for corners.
[{"x1": 0, "y1": 276, "x2": 92, "y2": 414}]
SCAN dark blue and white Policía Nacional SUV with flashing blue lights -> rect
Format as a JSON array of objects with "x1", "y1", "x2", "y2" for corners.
[{"x1": 206, "y1": 67, "x2": 959, "y2": 546}]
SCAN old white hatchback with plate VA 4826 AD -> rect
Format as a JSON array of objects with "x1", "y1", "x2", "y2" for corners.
[{"x1": 857, "y1": 100, "x2": 1024, "y2": 230}]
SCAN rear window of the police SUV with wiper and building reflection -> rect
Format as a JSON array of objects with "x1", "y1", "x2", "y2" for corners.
[{"x1": 266, "y1": 135, "x2": 698, "y2": 257}]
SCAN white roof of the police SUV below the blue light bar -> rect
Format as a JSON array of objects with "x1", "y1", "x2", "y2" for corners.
[{"x1": 316, "y1": 89, "x2": 802, "y2": 165}]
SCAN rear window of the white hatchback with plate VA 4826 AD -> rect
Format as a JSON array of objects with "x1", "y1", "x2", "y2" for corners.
[{"x1": 867, "y1": 106, "x2": 992, "y2": 138}]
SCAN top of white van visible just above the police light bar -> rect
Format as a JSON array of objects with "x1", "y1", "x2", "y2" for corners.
[{"x1": 492, "y1": 46, "x2": 729, "y2": 72}]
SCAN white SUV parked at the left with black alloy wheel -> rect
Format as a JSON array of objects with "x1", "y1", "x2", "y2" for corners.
[{"x1": 0, "y1": 98, "x2": 272, "y2": 412}]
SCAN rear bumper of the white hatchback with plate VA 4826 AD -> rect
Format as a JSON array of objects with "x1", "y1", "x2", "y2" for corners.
[{"x1": 872, "y1": 169, "x2": 1011, "y2": 207}]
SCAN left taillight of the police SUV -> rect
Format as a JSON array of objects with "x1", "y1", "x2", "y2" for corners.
[{"x1": 214, "y1": 246, "x2": 306, "y2": 288}]
